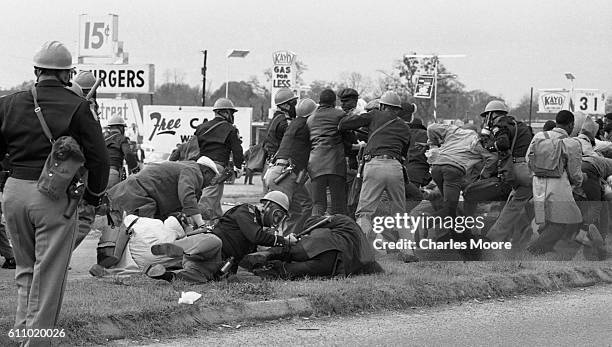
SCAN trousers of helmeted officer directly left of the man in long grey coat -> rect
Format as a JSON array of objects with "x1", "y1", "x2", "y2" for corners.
[{"x1": 265, "y1": 165, "x2": 312, "y2": 235}]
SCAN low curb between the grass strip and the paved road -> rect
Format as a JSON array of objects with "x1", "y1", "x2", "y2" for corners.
[{"x1": 68, "y1": 267, "x2": 612, "y2": 341}]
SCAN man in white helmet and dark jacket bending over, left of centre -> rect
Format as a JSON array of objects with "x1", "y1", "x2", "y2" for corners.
[{"x1": 90, "y1": 157, "x2": 219, "y2": 276}]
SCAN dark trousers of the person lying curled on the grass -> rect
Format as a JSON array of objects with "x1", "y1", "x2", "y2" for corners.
[{"x1": 284, "y1": 245, "x2": 339, "y2": 278}]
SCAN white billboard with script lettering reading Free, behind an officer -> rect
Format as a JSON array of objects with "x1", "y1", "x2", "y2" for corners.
[{"x1": 141, "y1": 105, "x2": 253, "y2": 153}]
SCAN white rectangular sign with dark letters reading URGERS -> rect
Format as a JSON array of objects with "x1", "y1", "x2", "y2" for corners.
[{"x1": 77, "y1": 64, "x2": 155, "y2": 94}]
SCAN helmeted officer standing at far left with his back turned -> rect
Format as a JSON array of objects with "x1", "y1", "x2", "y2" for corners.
[{"x1": 0, "y1": 41, "x2": 109, "y2": 345}]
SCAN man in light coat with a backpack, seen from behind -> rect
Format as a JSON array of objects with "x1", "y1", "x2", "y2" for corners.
[{"x1": 526, "y1": 110, "x2": 583, "y2": 257}]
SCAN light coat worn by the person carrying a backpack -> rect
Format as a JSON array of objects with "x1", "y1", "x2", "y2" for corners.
[{"x1": 525, "y1": 128, "x2": 582, "y2": 224}]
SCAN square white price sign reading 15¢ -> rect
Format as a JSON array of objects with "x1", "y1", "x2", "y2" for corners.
[{"x1": 79, "y1": 14, "x2": 119, "y2": 57}]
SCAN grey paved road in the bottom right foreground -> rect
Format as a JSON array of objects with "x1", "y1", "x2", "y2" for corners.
[{"x1": 145, "y1": 286, "x2": 612, "y2": 346}]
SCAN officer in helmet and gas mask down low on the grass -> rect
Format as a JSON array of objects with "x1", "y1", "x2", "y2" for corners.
[{"x1": 145, "y1": 191, "x2": 295, "y2": 282}]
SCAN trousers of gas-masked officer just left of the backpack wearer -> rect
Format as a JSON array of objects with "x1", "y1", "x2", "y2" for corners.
[{"x1": 487, "y1": 162, "x2": 535, "y2": 250}]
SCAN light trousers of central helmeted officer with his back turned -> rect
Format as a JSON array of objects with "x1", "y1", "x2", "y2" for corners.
[{"x1": 355, "y1": 158, "x2": 406, "y2": 241}]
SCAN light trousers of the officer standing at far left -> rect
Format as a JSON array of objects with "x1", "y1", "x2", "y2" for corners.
[{"x1": 3, "y1": 178, "x2": 77, "y2": 344}]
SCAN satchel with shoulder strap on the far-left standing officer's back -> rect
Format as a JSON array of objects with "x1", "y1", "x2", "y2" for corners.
[{"x1": 31, "y1": 87, "x2": 87, "y2": 200}]
